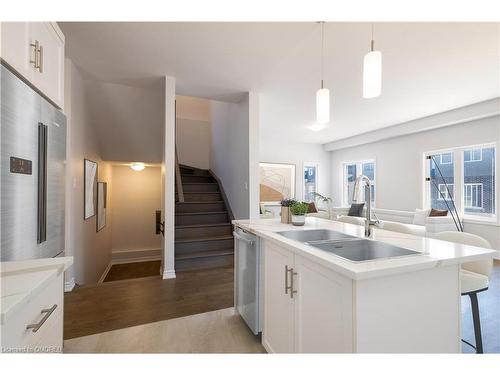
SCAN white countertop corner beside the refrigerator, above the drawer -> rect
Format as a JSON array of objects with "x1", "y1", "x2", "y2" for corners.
[{"x1": 0, "y1": 257, "x2": 73, "y2": 324}]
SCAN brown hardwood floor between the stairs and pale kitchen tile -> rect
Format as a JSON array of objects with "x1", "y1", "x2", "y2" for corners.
[{"x1": 64, "y1": 267, "x2": 234, "y2": 339}]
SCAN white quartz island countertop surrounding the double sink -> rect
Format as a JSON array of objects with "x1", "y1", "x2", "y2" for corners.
[{"x1": 233, "y1": 217, "x2": 498, "y2": 280}]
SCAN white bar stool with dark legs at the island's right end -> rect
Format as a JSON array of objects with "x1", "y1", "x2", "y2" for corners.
[{"x1": 436, "y1": 232, "x2": 493, "y2": 353}]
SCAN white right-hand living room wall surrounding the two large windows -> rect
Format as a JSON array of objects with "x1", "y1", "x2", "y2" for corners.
[{"x1": 331, "y1": 116, "x2": 500, "y2": 249}]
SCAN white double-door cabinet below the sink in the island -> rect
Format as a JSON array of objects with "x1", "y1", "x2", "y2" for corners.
[{"x1": 262, "y1": 241, "x2": 353, "y2": 353}]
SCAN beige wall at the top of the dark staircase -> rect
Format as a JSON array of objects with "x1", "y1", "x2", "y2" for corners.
[{"x1": 175, "y1": 95, "x2": 211, "y2": 169}]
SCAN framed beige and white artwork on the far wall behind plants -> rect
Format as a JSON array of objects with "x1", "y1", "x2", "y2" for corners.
[{"x1": 259, "y1": 162, "x2": 296, "y2": 206}]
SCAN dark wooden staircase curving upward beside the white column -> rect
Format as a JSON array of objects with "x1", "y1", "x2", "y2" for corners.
[{"x1": 175, "y1": 165, "x2": 234, "y2": 271}]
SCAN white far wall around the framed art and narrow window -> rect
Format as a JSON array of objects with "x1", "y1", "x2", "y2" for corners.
[{"x1": 260, "y1": 136, "x2": 331, "y2": 206}]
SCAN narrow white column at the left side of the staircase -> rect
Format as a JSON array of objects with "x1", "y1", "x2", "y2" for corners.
[{"x1": 162, "y1": 76, "x2": 175, "y2": 279}]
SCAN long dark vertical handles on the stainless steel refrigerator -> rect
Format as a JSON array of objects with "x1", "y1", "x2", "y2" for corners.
[{"x1": 37, "y1": 123, "x2": 48, "y2": 243}]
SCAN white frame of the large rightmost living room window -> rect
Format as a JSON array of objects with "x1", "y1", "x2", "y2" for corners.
[{"x1": 422, "y1": 142, "x2": 500, "y2": 225}]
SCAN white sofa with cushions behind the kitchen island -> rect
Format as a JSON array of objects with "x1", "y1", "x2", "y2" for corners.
[{"x1": 332, "y1": 207, "x2": 456, "y2": 237}]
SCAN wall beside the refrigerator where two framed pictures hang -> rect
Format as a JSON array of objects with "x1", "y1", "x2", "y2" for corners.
[{"x1": 64, "y1": 59, "x2": 112, "y2": 284}]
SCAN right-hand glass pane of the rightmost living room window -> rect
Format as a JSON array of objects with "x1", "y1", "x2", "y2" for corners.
[{"x1": 463, "y1": 147, "x2": 496, "y2": 218}]
